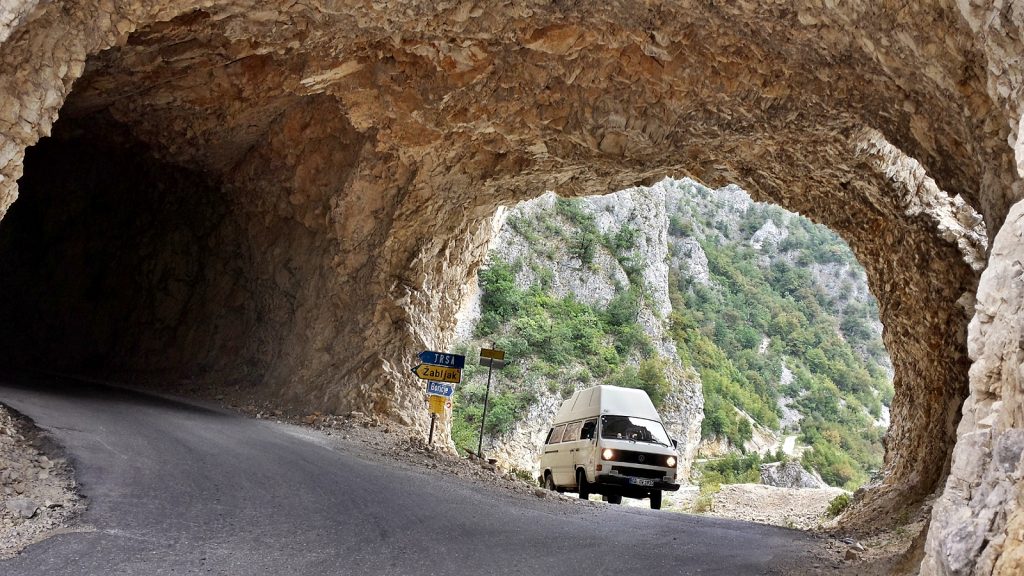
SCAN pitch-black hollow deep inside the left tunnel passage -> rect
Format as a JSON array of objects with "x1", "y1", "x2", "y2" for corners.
[{"x1": 0, "y1": 114, "x2": 230, "y2": 376}]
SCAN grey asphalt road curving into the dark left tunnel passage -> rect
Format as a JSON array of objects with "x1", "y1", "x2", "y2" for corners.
[{"x1": 0, "y1": 376, "x2": 813, "y2": 576}]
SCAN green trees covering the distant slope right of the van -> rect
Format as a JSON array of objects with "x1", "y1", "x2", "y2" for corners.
[{"x1": 670, "y1": 181, "x2": 892, "y2": 488}]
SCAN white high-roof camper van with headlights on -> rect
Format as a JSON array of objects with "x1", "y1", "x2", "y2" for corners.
[{"x1": 539, "y1": 385, "x2": 679, "y2": 509}]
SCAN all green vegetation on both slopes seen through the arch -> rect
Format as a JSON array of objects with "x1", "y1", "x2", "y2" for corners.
[{"x1": 453, "y1": 182, "x2": 893, "y2": 487}]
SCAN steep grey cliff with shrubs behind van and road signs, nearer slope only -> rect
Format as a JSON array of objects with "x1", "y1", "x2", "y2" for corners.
[{"x1": 453, "y1": 187, "x2": 702, "y2": 474}]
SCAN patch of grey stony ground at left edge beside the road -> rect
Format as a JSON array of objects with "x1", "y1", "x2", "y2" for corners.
[{"x1": 0, "y1": 404, "x2": 85, "y2": 560}]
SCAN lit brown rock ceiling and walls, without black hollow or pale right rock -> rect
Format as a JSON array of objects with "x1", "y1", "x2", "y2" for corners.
[{"x1": 0, "y1": 0, "x2": 1024, "y2": 569}]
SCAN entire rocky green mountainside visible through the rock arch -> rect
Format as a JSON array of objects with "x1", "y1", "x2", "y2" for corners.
[{"x1": 453, "y1": 179, "x2": 892, "y2": 486}]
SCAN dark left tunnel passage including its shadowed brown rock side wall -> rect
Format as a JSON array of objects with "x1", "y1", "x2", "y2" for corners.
[{"x1": 0, "y1": 6, "x2": 382, "y2": 411}]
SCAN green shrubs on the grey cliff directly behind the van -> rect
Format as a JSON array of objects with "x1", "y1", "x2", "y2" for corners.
[{"x1": 452, "y1": 200, "x2": 671, "y2": 451}]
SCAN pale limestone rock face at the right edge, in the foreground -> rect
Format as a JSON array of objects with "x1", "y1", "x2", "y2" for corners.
[{"x1": 922, "y1": 198, "x2": 1024, "y2": 575}]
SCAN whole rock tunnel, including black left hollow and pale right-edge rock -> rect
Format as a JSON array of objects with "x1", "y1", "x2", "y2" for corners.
[{"x1": 0, "y1": 0, "x2": 1024, "y2": 573}]
